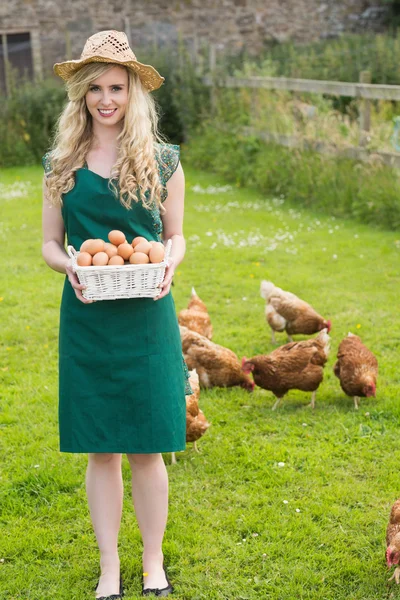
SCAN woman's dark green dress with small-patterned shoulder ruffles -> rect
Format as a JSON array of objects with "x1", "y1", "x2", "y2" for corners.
[{"x1": 42, "y1": 144, "x2": 192, "y2": 454}]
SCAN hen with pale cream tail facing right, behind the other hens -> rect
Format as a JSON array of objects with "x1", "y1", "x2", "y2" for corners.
[{"x1": 260, "y1": 281, "x2": 331, "y2": 344}]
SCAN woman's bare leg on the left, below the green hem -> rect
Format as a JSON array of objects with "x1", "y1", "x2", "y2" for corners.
[{"x1": 86, "y1": 453, "x2": 123, "y2": 597}]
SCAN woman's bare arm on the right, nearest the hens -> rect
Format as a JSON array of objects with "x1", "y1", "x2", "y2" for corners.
[{"x1": 155, "y1": 163, "x2": 186, "y2": 300}]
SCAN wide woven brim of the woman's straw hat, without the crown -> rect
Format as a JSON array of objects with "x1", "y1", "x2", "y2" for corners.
[{"x1": 53, "y1": 56, "x2": 165, "y2": 92}]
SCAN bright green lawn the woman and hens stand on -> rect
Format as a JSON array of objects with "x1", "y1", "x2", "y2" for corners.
[{"x1": 0, "y1": 167, "x2": 400, "y2": 600}]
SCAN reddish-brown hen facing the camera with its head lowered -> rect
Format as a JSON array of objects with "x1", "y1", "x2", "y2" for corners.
[{"x1": 333, "y1": 333, "x2": 378, "y2": 410}]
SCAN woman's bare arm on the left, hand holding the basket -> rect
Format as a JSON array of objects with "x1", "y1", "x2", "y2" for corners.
[{"x1": 42, "y1": 178, "x2": 92, "y2": 304}]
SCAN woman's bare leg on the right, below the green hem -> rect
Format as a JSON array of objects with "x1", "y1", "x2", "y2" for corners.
[{"x1": 127, "y1": 454, "x2": 168, "y2": 589}]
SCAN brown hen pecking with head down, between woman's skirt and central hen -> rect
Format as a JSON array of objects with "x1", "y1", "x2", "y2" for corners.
[{"x1": 180, "y1": 326, "x2": 254, "y2": 392}]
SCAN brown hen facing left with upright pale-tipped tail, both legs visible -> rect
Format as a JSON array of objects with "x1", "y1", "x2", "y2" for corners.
[{"x1": 242, "y1": 329, "x2": 330, "y2": 410}]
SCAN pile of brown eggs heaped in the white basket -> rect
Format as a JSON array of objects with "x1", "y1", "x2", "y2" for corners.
[{"x1": 76, "y1": 229, "x2": 164, "y2": 267}]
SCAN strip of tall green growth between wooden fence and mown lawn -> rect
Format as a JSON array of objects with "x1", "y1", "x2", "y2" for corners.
[{"x1": 185, "y1": 121, "x2": 400, "y2": 230}]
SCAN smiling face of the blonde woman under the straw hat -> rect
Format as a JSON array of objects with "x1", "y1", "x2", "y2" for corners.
[{"x1": 85, "y1": 66, "x2": 128, "y2": 127}]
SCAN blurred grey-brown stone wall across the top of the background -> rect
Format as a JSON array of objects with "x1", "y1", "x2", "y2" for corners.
[{"x1": 0, "y1": 0, "x2": 388, "y2": 79}]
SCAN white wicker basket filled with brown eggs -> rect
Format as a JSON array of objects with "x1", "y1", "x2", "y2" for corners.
[{"x1": 67, "y1": 230, "x2": 172, "y2": 300}]
